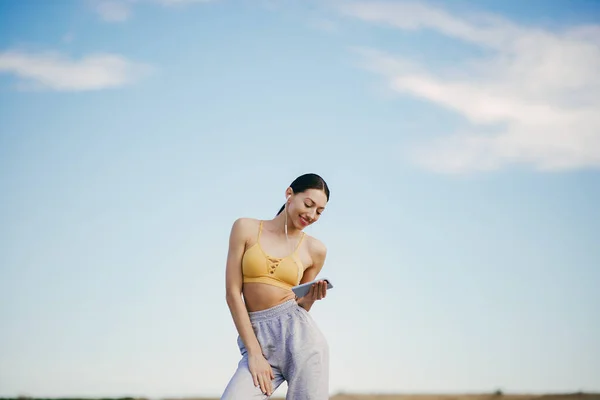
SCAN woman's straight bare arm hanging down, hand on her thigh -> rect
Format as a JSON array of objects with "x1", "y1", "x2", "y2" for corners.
[{"x1": 225, "y1": 218, "x2": 275, "y2": 396}]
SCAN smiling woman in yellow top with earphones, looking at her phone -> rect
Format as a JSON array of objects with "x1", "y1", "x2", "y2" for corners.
[{"x1": 221, "y1": 174, "x2": 329, "y2": 400}]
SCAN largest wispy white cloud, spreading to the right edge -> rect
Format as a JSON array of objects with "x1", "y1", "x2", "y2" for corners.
[{"x1": 341, "y1": 1, "x2": 600, "y2": 172}]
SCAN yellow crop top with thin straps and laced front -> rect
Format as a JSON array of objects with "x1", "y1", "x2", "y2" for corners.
[{"x1": 242, "y1": 221, "x2": 305, "y2": 289}]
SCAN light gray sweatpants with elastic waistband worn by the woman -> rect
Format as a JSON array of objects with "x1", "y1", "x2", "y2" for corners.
[{"x1": 221, "y1": 300, "x2": 329, "y2": 400}]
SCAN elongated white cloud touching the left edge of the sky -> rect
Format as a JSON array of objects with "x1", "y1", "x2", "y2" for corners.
[{"x1": 0, "y1": 51, "x2": 151, "y2": 91}]
